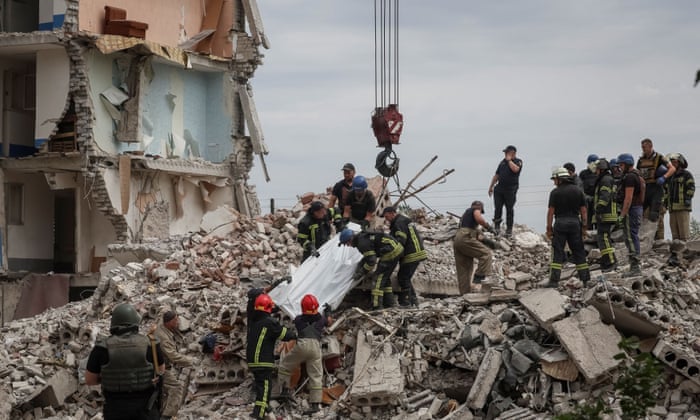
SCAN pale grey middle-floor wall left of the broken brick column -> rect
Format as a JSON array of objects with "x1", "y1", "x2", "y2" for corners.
[{"x1": 34, "y1": 49, "x2": 70, "y2": 146}]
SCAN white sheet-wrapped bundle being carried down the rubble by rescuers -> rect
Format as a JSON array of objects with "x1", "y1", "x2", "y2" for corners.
[{"x1": 270, "y1": 230, "x2": 362, "y2": 318}]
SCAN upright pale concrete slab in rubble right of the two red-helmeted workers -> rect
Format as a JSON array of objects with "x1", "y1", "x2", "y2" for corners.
[{"x1": 350, "y1": 331, "x2": 404, "y2": 407}]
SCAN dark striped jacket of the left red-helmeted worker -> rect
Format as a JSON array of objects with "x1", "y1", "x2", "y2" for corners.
[{"x1": 246, "y1": 310, "x2": 297, "y2": 368}]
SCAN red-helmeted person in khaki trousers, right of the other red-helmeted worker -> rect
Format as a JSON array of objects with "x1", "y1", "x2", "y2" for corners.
[{"x1": 277, "y1": 294, "x2": 332, "y2": 414}]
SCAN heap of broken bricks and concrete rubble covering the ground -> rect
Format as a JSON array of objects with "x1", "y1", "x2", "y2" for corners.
[{"x1": 0, "y1": 202, "x2": 700, "y2": 420}]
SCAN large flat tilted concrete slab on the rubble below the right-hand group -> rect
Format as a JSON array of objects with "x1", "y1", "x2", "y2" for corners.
[{"x1": 552, "y1": 306, "x2": 622, "y2": 382}]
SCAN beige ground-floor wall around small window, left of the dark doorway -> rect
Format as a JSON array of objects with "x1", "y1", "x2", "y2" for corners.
[{"x1": 5, "y1": 171, "x2": 54, "y2": 259}]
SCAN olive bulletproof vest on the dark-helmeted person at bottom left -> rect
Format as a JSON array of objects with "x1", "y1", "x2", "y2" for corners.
[{"x1": 96, "y1": 334, "x2": 154, "y2": 392}]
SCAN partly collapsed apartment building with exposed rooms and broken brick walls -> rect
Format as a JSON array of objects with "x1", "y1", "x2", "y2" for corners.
[{"x1": 0, "y1": 0, "x2": 268, "y2": 322}]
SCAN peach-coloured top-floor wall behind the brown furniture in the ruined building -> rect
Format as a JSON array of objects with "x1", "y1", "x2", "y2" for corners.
[{"x1": 78, "y1": 0, "x2": 205, "y2": 46}]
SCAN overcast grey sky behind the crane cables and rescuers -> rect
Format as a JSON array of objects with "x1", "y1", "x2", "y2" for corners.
[{"x1": 251, "y1": 0, "x2": 700, "y2": 232}]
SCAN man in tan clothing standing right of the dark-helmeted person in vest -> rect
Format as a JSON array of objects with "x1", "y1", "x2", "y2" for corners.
[{"x1": 155, "y1": 311, "x2": 195, "y2": 419}]
